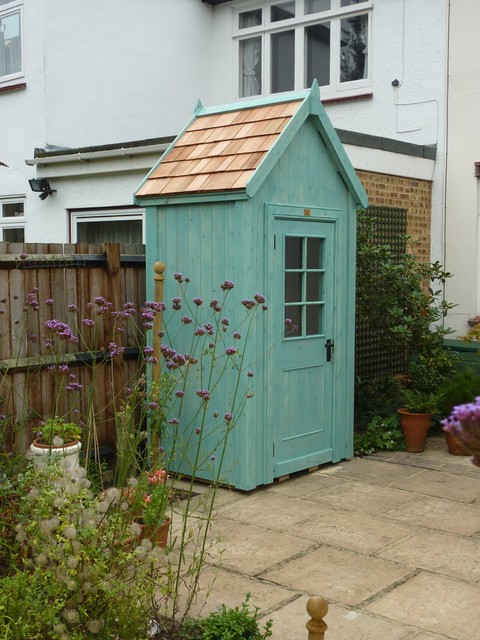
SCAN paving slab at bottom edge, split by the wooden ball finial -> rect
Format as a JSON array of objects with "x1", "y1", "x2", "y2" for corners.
[{"x1": 265, "y1": 595, "x2": 414, "y2": 640}]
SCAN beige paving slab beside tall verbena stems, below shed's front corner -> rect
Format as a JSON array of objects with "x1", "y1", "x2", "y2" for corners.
[{"x1": 205, "y1": 518, "x2": 312, "y2": 576}]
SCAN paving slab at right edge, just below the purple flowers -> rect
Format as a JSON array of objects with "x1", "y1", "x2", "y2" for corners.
[{"x1": 394, "y1": 470, "x2": 480, "y2": 503}]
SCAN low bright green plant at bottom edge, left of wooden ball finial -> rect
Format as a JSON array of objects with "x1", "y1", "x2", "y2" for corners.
[{"x1": 201, "y1": 593, "x2": 272, "y2": 640}]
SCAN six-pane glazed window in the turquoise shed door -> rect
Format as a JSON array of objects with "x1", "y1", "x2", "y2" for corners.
[{"x1": 284, "y1": 236, "x2": 325, "y2": 338}]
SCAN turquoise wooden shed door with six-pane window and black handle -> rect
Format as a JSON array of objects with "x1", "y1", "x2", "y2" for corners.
[{"x1": 268, "y1": 219, "x2": 336, "y2": 477}]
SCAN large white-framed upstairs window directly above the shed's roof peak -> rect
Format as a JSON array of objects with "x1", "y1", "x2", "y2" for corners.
[{"x1": 235, "y1": 0, "x2": 372, "y2": 98}]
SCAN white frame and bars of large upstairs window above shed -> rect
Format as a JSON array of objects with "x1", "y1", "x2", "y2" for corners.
[{"x1": 233, "y1": 0, "x2": 373, "y2": 99}]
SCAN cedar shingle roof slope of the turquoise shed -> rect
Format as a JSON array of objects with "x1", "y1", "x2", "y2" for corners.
[{"x1": 136, "y1": 99, "x2": 302, "y2": 197}]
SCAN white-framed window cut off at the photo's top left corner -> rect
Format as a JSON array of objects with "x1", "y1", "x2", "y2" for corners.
[{"x1": 0, "y1": 0, "x2": 23, "y2": 87}]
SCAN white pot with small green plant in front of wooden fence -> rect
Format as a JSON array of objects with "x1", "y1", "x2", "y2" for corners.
[{"x1": 30, "y1": 416, "x2": 82, "y2": 473}]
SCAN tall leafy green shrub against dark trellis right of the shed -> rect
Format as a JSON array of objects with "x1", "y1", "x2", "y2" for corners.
[{"x1": 357, "y1": 210, "x2": 453, "y2": 358}]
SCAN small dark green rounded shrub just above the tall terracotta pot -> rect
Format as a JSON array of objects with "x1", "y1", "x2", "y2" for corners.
[{"x1": 408, "y1": 347, "x2": 460, "y2": 393}]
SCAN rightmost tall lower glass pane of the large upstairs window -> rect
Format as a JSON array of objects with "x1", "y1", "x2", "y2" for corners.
[{"x1": 340, "y1": 15, "x2": 368, "y2": 82}]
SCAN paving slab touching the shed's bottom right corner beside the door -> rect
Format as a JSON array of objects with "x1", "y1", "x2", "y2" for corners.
[{"x1": 314, "y1": 458, "x2": 422, "y2": 487}]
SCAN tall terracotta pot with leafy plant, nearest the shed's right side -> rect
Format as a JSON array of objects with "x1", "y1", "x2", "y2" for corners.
[{"x1": 397, "y1": 389, "x2": 440, "y2": 453}]
